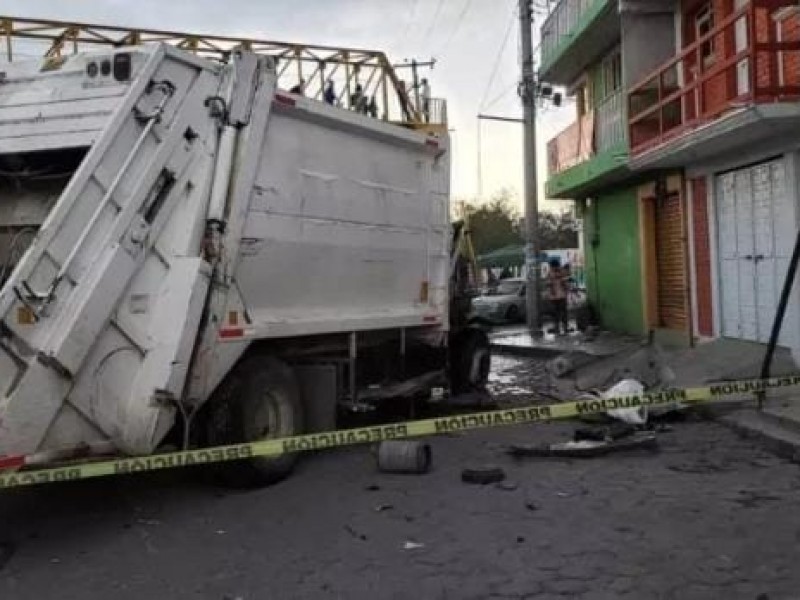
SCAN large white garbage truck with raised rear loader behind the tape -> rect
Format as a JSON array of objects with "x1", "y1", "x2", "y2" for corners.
[{"x1": 0, "y1": 37, "x2": 489, "y2": 484}]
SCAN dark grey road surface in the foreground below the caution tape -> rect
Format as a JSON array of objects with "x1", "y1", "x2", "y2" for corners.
[{"x1": 0, "y1": 380, "x2": 800, "y2": 600}]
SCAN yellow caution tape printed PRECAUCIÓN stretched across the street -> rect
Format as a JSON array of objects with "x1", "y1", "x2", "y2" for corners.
[{"x1": 0, "y1": 375, "x2": 800, "y2": 488}]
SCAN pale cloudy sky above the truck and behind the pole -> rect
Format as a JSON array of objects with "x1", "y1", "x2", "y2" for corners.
[{"x1": 0, "y1": 0, "x2": 574, "y2": 210}]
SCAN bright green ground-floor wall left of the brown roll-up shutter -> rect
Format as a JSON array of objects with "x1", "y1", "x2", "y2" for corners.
[{"x1": 582, "y1": 188, "x2": 645, "y2": 334}]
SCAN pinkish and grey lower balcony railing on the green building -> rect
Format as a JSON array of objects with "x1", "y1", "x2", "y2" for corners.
[{"x1": 547, "y1": 92, "x2": 625, "y2": 175}]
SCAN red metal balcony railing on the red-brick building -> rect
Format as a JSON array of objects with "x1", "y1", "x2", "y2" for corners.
[{"x1": 627, "y1": 0, "x2": 800, "y2": 155}]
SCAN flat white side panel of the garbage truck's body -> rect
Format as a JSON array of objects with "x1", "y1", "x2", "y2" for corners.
[{"x1": 236, "y1": 103, "x2": 449, "y2": 335}]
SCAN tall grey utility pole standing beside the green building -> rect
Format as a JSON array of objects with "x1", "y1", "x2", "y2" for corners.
[{"x1": 519, "y1": 0, "x2": 541, "y2": 336}]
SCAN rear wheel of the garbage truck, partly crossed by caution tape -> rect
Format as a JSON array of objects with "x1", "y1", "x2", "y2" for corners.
[{"x1": 206, "y1": 355, "x2": 303, "y2": 487}]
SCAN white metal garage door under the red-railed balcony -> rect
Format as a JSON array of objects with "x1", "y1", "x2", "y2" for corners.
[{"x1": 716, "y1": 159, "x2": 797, "y2": 346}]
